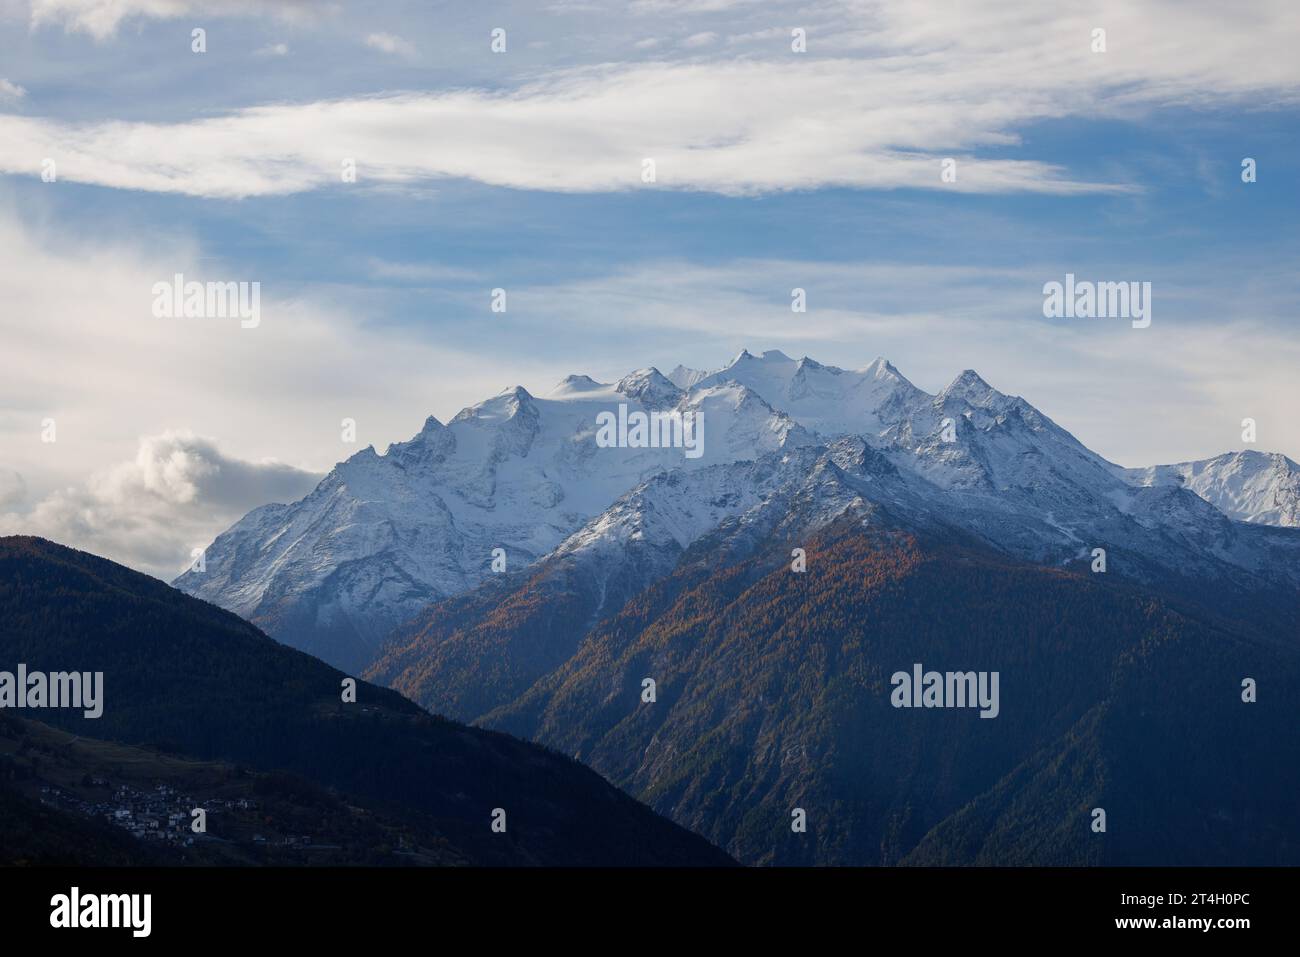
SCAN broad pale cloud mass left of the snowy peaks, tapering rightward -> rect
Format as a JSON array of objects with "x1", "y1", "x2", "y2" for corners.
[{"x1": 0, "y1": 204, "x2": 559, "y2": 577}]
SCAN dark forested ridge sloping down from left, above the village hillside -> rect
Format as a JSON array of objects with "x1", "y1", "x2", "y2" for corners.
[{"x1": 0, "y1": 537, "x2": 728, "y2": 865}]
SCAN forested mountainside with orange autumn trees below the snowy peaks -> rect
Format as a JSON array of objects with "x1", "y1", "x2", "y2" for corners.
[{"x1": 371, "y1": 524, "x2": 1300, "y2": 865}]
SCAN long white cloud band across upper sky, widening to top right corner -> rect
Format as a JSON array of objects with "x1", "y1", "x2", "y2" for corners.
[{"x1": 0, "y1": 0, "x2": 1300, "y2": 198}]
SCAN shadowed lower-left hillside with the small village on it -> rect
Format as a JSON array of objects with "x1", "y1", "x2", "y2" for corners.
[{"x1": 0, "y1": 711, "x2": 472, "y2": 866}]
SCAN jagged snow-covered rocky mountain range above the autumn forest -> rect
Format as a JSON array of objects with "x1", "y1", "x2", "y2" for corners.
[{"x1": 176, "y1": 351, "x2": 1300, "y2": 668}]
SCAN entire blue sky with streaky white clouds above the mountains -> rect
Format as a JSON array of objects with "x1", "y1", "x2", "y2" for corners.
[{"x1": 0, "y1": 0, "x2": 1300, "y2": 570}]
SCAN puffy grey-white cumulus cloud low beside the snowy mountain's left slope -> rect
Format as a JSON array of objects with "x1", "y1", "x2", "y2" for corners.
[{"x1": 0, "y1": 432, "x2": 320, "y2": 579}]
